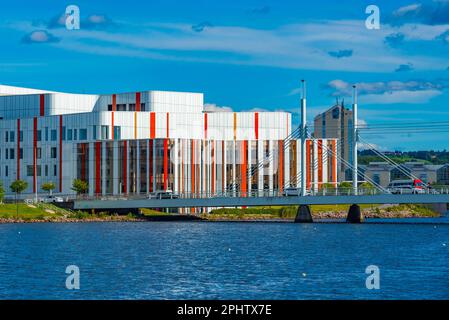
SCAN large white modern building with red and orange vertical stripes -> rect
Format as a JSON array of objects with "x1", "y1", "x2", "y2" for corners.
[{"x1": 0, "y1": 85, "x2": 339, "y2": 199}]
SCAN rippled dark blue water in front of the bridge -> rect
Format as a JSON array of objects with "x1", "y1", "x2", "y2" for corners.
[{"x1": 0, "y1": 218, "x2": 449, "y2": 299}]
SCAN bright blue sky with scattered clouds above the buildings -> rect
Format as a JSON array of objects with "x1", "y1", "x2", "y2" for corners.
[{"x1": 0, "y1": 0, "x2": 449, "y2": 150}]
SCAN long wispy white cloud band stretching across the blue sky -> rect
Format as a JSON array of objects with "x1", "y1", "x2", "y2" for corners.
[{"x1": 7, "y1": 20, "x2": 447, "y2": 72}]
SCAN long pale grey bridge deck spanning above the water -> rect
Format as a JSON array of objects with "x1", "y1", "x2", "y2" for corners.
[{"x1": 74, "y1": 194, "x2": 449, "y2": 210}]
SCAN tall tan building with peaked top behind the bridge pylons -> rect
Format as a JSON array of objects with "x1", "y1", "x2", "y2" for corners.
[{"x1": 313, "y1": 100, "x2": 353, "y2": 181}]
